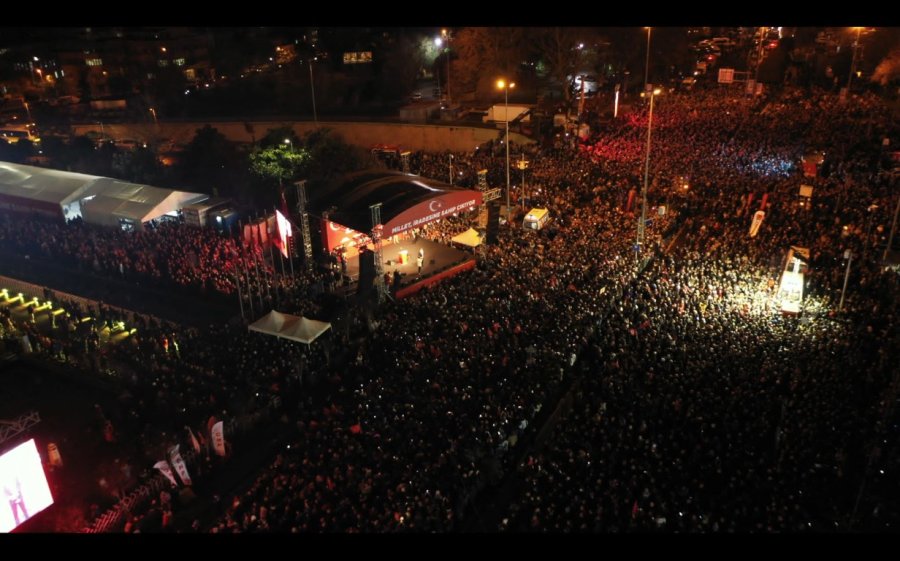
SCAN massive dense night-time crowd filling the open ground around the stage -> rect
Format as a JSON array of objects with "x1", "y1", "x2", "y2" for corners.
[{"x1": 0, "y1": 82, "x2": 900, "y2": 532}]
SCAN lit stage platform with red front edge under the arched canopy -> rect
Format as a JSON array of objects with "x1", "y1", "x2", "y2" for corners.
[{"x1": 347, "y1": 238, "x2": 475, "y2": 299}]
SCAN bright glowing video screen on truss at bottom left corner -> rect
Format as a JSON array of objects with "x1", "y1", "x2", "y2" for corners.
[{"x1": 0, "y1": 439, "x2": 53, "y2": 532}]
